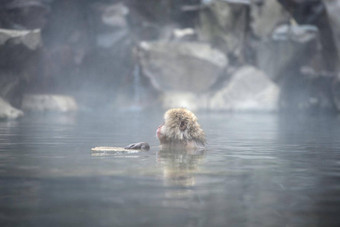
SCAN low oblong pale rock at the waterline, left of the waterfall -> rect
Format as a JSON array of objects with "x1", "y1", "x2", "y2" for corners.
[{"x1": 22, "y1": 95, "x2": 78, "y2": 113}]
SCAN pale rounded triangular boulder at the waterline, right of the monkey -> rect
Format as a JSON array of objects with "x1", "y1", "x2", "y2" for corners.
[{"x1": 209, "y1": 66, "x2": 279, "y2": 112}]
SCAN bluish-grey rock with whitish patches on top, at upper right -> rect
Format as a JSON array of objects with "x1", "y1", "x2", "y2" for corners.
[{"x1": 257, "y1": 25, "x2": 320, "y2": 81}]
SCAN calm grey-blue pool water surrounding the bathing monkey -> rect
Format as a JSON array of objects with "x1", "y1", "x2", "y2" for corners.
[{"x1": 0, "y1": 113, "x2": 340, "y2": 226}]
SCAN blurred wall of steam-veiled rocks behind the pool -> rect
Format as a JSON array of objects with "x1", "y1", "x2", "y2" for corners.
[{"x1": 0, "y1": 0, "x2": 340, "y2": 118}]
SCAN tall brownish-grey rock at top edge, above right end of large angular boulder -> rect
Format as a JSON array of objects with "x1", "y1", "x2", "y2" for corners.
[{"x1": 199, "y1": 1, "x2": 249, "y2": 61}]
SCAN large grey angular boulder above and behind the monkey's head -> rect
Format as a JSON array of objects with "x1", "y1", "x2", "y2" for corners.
[{"x1": 138, "y1": 42, "x2": 228, "y2": 92}]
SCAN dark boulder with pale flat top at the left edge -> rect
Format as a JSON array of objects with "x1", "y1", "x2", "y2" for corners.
[{"x1": 0, "y1": 29, "x2": 42, "y2": 107}]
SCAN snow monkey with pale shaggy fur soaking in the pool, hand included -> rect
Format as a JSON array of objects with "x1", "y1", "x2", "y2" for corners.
[{"x1": 126, "y1": 108, "x2": 206, "y2": 150}]
